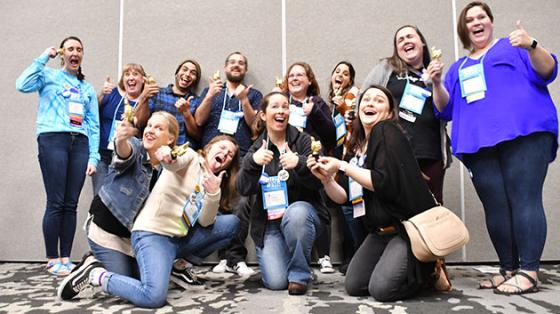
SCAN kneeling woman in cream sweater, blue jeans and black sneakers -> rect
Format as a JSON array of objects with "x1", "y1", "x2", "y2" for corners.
[{"x1": 59, "y1": 131, "x2": 239, "y2": 308}]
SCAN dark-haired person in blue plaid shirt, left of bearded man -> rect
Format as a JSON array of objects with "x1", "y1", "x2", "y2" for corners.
[{"x1": 135, "y1": 59, "x2": 202, "y2": 150}]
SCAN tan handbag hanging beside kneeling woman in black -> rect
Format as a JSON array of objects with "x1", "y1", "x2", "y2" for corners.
[{"x1": 402, "y1": 206, "x2": 469, "y2": 262}]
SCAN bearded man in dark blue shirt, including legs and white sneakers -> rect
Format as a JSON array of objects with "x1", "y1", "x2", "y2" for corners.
[{"x1": 193, "y1": 51, "x2": 262, "y2": 276}]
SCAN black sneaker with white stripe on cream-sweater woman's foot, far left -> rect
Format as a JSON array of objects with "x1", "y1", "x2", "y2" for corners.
[{"x1": 57, "y1": 254, "x2": 103, "y2": 300}]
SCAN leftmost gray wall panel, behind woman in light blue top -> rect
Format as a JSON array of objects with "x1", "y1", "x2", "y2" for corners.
[{"x1": 0, "y1": 0, "x2": 118, "y2": 260}]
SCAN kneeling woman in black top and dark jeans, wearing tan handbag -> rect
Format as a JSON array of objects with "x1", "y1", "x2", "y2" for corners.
[{"x1": 308, "y1": 85, "x2": 436, "y2": 301}]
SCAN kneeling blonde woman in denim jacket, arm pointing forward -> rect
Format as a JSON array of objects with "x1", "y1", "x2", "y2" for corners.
[{"x1": 87, "y1": 111, "x2": 179, "y2": 278}]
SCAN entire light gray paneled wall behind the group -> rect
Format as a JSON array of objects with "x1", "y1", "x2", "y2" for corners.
[{"x1": 0, "y1": 0, "x2": 560, "y2": 261}]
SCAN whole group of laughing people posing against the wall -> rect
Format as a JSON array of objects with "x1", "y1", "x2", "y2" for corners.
[{"x1": 16, "y1": 1, "x2": 558, "y2": 307}]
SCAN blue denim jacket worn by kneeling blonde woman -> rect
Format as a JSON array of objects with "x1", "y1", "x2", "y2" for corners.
[{"x1": 99, "y1": 137, "x2": 152, "y2": 230}]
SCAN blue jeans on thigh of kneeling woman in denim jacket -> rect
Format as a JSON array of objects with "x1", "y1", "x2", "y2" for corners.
[{"x1": 88, "y1": 239, "x2": 140, "y2": 279}]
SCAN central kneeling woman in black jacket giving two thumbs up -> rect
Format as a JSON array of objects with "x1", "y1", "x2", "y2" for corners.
[{"x1": 237, "y1": 92, "x2": 328, "y2": 294}]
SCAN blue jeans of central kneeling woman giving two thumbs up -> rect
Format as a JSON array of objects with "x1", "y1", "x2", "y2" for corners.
[{"x1": 257, "y1": 202, "x2": 322, "y2": 290}]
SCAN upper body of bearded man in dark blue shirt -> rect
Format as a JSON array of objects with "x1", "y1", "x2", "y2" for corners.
[{"x1": 193, "y1": 51, "x2": 262, "y2": 157}]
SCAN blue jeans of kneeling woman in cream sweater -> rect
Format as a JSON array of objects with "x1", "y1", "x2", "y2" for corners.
[{"x1": 103, "y1": 215, "x2": 239, "y2": 308}]
